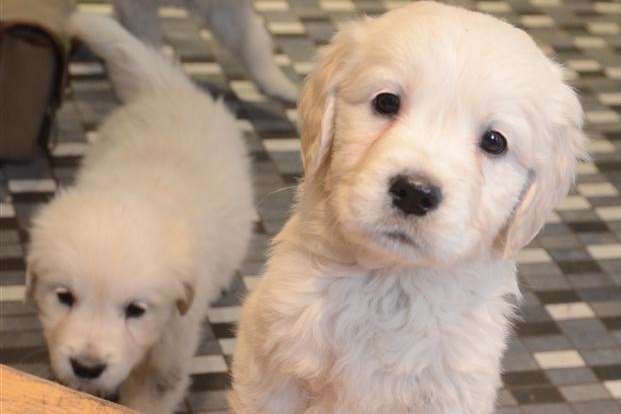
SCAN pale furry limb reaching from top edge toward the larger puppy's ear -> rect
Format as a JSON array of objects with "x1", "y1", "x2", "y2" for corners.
[{"x1": 186, "y1": 0, "x2": 298, "y2": 103}]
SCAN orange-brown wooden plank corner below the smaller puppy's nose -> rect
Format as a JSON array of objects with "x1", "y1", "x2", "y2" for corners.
[{"x1": 0, "y1": 365, "x2": 136, "y2": 414}]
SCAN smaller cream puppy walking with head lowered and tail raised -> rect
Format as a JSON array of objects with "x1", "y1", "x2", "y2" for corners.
[{"x1": 28, "y1": 14, "x2": 254, "y2": 414}]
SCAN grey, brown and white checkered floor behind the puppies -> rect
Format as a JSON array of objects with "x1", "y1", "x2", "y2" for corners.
[{"x1": 0, "y1": 0, "x2": 621, "y2": 414}]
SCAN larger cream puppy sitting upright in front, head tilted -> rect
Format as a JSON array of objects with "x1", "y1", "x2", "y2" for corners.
[{"x1": 230, "y1": 2, "x2": 586, "y2": 414}]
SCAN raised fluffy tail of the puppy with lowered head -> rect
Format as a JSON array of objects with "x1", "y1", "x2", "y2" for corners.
[{"x1": 69, "y1": 12, "x2": 192, "y2": 102}]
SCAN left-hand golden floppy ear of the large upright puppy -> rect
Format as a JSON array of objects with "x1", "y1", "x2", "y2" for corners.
[{"x1": 298, "y1": 23, "x2": 364, "y2": 180}]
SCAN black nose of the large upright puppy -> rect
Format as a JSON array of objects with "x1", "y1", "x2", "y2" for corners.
[{"x1": 389, "y1": 176, "x2": 442, "y2": 216}]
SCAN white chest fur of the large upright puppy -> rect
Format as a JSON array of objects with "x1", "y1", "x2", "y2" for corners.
[{"x1": 317, "y1": 269, "x2": 513, "y2": 413}]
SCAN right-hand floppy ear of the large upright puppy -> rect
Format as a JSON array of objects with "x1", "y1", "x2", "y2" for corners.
[{"x1": 502, "y1": 79, "x2": 589, "y2": 258}]
